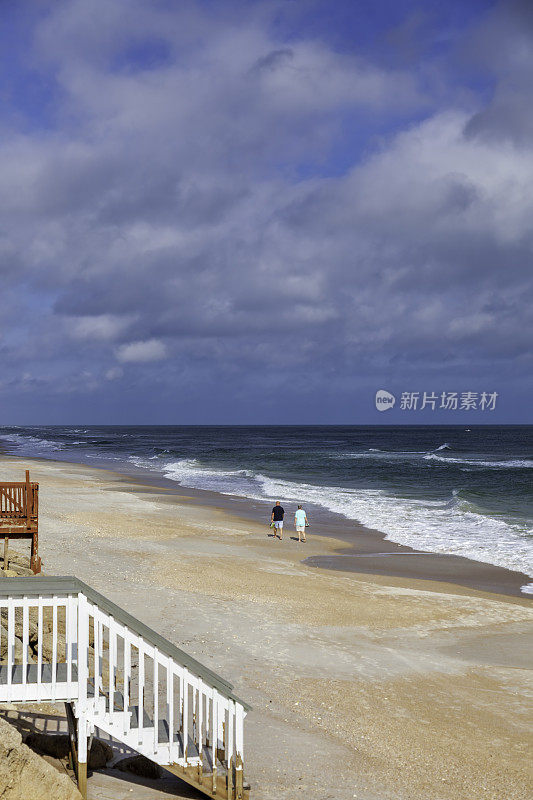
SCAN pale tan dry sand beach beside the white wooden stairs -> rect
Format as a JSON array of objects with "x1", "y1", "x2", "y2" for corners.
[{"x1": 0, "y1": 456, "x2": 533, "y2": 800}]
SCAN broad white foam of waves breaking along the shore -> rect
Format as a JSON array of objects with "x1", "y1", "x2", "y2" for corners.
[{"x1": 130, "y1": 459, "x2": 533, "y2": 577}]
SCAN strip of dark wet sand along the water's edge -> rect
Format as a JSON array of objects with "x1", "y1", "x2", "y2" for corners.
[{"x1": 0, "y1": 453, "x2": 533, "y2": 600}]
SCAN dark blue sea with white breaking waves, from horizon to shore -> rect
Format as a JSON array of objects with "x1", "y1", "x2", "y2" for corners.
[{"x1": 0, "y1": 426, "x2": 533, "y2": 588}]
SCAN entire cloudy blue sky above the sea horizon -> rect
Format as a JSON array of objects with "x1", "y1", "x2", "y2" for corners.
[{"x1": 0, "y1": 0, "x2": 533, "y2": 425}]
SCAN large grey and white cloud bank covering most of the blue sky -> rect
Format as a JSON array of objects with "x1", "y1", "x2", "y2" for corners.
[{"x1": 0, "y1": 0, "x2": 533, "y2": 422}]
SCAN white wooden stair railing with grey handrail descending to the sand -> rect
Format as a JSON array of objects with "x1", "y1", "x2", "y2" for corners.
[{"x1": 0, "y1": 578, "x2": 249, "y2": 800}]
